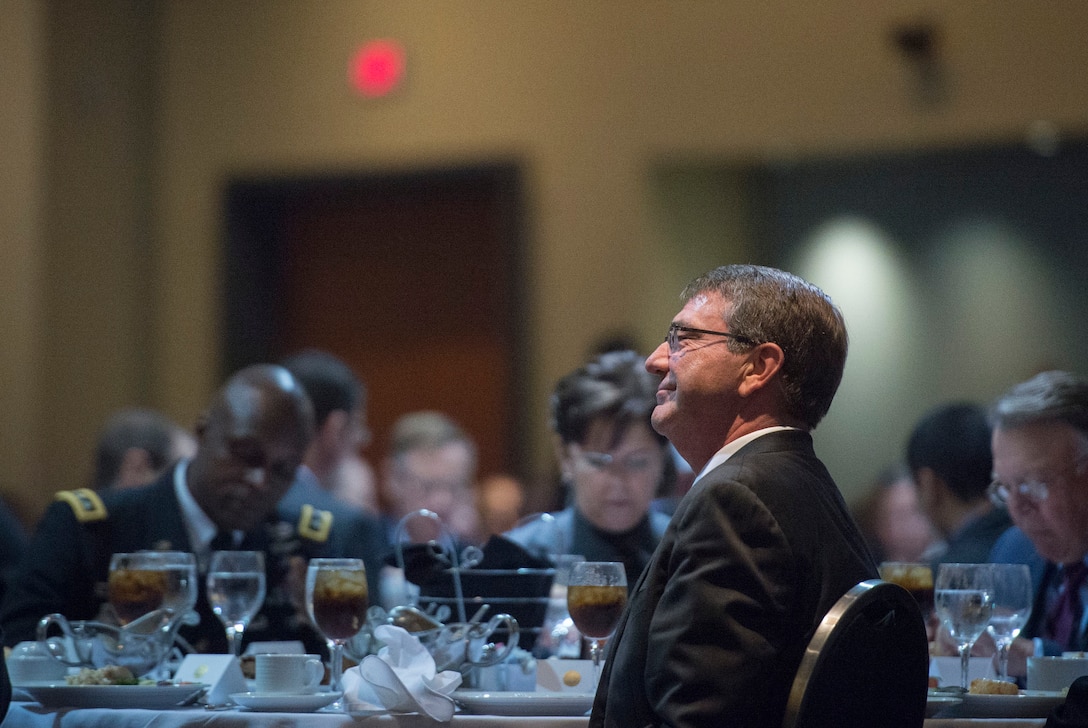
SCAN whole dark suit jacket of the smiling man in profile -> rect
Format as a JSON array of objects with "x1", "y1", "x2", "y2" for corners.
[{"x1": 591, "y1": 431, "x2": 876, "y2": 727}]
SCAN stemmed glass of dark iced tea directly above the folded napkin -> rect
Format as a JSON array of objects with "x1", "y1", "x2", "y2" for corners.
[{"x1": 306, "y1": 558, "x2": 370, "y2": 710}]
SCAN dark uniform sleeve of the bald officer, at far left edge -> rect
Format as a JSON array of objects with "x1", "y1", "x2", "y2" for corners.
[{"x1": 0, "y1": 503, "x2": 98, "y2": 645}]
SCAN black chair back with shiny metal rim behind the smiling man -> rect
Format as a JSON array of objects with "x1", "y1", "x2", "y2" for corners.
[{"x1": 782, "y1": 579, "x2": 929, "y2": 728}]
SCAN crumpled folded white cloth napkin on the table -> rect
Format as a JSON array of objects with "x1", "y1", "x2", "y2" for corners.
[{"x1": 343, "y1": 625, "x2": 461, "y2": 723}]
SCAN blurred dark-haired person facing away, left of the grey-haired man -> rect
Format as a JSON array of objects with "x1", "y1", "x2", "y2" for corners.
[{"x1": 906, "y1": 403, "x2": 1012, "y2": 566}]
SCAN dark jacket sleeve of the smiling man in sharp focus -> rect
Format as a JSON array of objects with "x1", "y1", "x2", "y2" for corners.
[{"x1": 644, "y1": 476, "x2": 796, "y2": 727}]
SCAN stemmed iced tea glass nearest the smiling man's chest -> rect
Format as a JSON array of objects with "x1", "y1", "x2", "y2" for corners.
[{"x1": 567, "y1": 562, "x2": 627, "y2": 680}]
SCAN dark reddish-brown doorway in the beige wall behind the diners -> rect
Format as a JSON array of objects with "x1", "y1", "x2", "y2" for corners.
[{"x1": 224, "y1": 165, "x2": 528, "y2": 480}]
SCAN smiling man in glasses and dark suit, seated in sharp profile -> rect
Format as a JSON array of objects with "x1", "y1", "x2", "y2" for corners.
[{"x1": 590, "y1": 266, "x2": 877, "y2": 728}]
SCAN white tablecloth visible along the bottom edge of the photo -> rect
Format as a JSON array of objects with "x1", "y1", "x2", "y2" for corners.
[{"x1": 0, "y1": 702, "x2": 1047, "y2": 728}]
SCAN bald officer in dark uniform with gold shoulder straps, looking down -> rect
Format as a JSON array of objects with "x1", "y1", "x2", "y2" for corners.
[{"x1": 0, "y1": 365, "x2": 380, "y2": 652}]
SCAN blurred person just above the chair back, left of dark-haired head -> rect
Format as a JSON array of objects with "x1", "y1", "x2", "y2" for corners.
[{"x1": 853, "y1": 465, "x2": 942, "y2": 564}]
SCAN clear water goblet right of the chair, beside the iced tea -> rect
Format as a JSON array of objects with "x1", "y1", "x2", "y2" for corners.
[{"x1": 935, "y1": 564, "x2": 993, "y2": 692}]
